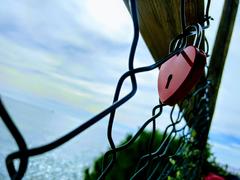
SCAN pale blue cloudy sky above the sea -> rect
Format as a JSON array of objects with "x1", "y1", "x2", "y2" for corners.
[{"x1": 0, "y1": 0, "x2": 240, "y2": 173}]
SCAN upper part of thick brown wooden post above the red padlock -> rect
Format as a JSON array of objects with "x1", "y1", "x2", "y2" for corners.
[{"x1": 123, "y1": 0, "x2": 204, "y2": 61}]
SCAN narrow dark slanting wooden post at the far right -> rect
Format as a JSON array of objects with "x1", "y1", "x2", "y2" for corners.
[{"x1": 199, "y1": 0, "x2": 239, "y2": 147}]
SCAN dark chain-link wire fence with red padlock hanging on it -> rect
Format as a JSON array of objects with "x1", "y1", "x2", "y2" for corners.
[{"x1": 0, "y1": 0, "x2": 215, "y2": 179}]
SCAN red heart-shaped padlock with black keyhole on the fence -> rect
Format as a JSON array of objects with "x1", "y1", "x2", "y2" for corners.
[{"x1": 158, "y1": 24, "x2": 206, "y2": 105}]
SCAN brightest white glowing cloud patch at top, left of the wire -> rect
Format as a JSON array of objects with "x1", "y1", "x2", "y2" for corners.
[{"x1": 81, "y1": 0, "x2": 133, "y2": 42}]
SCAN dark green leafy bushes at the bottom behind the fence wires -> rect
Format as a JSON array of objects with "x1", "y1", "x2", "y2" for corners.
[{"x1": 84, "y1": 131, "x2": 237, "y2": 180}]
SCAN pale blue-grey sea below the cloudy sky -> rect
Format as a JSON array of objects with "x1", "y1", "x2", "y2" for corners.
[{"x1": 0, "y1": 96, "x2": 240, "y2": 180}]
